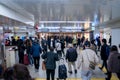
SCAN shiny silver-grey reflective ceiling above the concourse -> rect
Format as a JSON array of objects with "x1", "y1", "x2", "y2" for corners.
[{"x1": 0, "y1": 0, "x2": 120, "y2": 22}]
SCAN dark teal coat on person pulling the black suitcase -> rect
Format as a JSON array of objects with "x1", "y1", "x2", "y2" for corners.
[{"x1": 42, "y1": 52, "x2": 59, "y2": 70}]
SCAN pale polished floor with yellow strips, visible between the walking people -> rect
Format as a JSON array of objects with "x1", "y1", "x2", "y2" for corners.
[{"x1": 28, "y1": 49, "x2": 118, "y2": 80}]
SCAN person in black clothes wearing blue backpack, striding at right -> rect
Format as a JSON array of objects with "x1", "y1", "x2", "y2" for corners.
[{"x1": 100, "y1": 39, "x2": 110, "y2": 73}]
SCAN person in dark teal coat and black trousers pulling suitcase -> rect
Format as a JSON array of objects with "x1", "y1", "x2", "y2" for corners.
[{"x1": 42, "y1": 47, "x2": 59, "y2": 80}]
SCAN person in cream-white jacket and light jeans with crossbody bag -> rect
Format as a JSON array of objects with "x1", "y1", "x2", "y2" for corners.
[{"x1": 78, "y1": 44, "x2": 99, "y2": 80}]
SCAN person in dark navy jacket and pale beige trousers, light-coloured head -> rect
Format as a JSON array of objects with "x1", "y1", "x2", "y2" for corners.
[{"x1": 66, "y1": 44, "x2": 78, "y2": 74}]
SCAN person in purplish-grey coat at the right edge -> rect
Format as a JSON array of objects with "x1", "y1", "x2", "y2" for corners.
[{"x1": 107, "y1": 45, "x2": 120, "y2": 80}]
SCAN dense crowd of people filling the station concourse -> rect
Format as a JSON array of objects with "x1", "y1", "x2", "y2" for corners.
[{"x1": 0, "y1": 36, "x2": 120, "y2": 80}]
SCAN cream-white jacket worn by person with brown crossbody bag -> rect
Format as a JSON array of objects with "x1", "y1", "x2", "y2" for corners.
[{"x1": 78, "y1": 49, "x2": 99, "y2": 71}]
